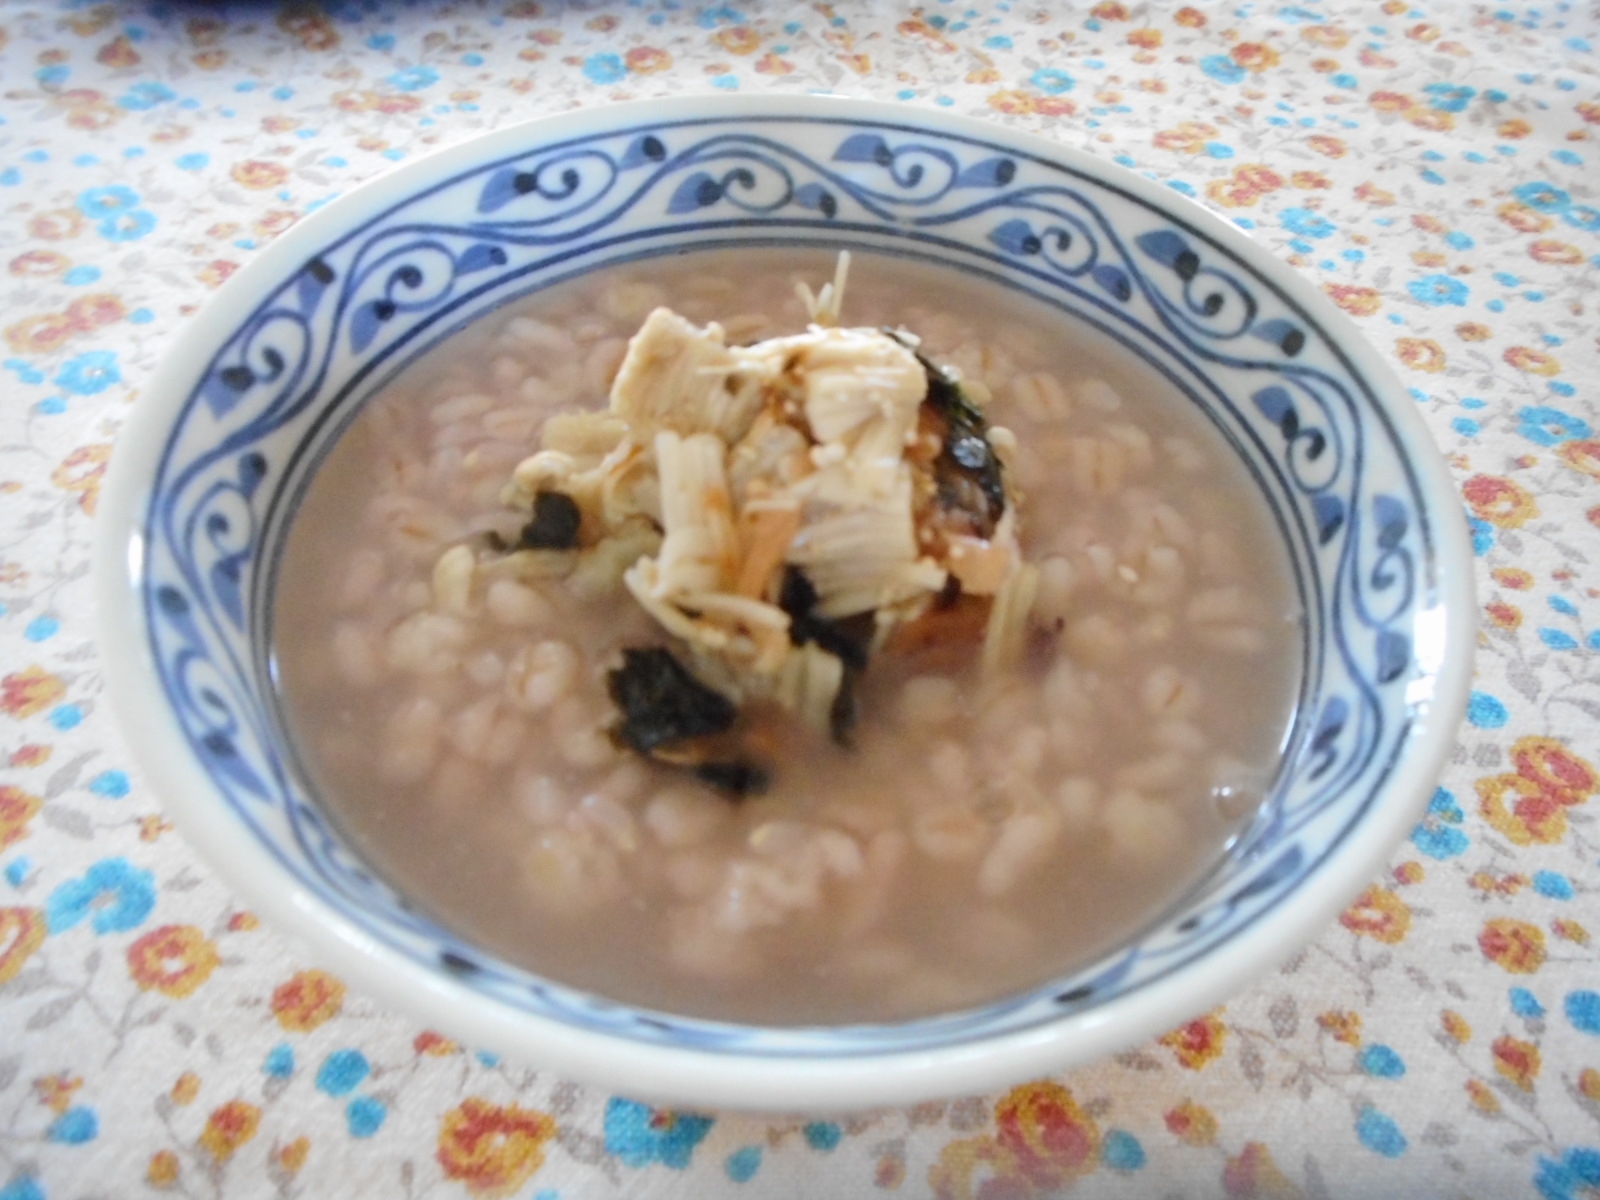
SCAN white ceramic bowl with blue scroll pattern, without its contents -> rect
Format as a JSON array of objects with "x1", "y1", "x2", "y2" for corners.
[{"x1": 96, "y1": 96, "x2": 1474, "y2": 1110}]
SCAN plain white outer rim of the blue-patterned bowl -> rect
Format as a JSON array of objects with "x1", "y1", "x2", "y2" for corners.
[{"x1": 93, "y1": 93, "x2": 1475, "y2": 1112}]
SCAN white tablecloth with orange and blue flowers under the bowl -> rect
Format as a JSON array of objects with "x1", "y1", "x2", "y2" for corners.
[{"x1": 0, "y1": 0, "x2": 1600, "y2": 1200}]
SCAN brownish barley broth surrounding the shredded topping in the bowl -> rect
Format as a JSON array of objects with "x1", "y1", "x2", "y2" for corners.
[{"x1": 275, "y1": 250, "x2": 1301, "y2": 1024}]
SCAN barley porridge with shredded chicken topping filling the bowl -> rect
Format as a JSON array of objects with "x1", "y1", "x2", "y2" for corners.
[{"x1": 275, "y1": 250, "x2": 1301, "y2": 1024}]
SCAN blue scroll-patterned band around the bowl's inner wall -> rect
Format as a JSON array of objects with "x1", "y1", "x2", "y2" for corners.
[{"x1": 144, "y1": 118, "x2": 1427, "y2": 1053}]
